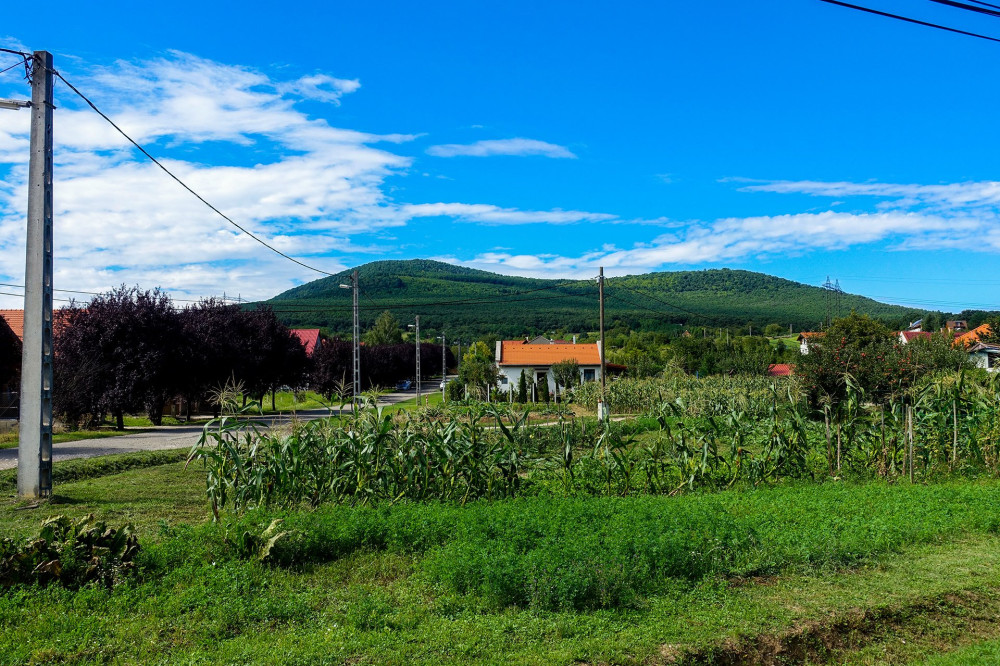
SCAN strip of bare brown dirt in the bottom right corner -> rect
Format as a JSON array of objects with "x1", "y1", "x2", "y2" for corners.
[{"x1": 652, "y1": 589, "x2": 1000, "y2": 666}]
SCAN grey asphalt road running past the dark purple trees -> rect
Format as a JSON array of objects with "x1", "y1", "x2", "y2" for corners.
[{"x1": 0, "y1": 391, "x2": 422, "y2": 470}]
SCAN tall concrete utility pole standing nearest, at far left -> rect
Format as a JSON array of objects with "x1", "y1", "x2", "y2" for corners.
[{"x1": 17, "y1": 51, "x2": 54, "y2": 498}]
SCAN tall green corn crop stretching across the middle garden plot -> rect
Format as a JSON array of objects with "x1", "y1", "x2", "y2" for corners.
[{"x1": 184, "y1": 374, "x2": 1000, "y2": 511}]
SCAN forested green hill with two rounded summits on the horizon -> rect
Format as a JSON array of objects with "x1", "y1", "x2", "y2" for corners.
[{"x1": 267, "y1": 259, "x2": 923, "y2": 339}]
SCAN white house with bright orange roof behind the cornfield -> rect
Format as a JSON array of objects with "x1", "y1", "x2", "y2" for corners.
[{"x1": 496, "y1": 338, "x2": 604, "y2": 393}]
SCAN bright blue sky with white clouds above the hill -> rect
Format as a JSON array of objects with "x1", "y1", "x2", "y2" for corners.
[{"x1": 0, "y1": 0, "x2": 1000, "y2": 311}]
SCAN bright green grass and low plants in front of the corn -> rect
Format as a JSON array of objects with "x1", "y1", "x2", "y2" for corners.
[{"x1": 0, "y1": 463, "x2": 1000, "y2": 664}]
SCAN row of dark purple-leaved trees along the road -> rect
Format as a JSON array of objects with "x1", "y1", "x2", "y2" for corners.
[{"x1": 0, "y1": 286, "x2": 455, "y2": 429}]
